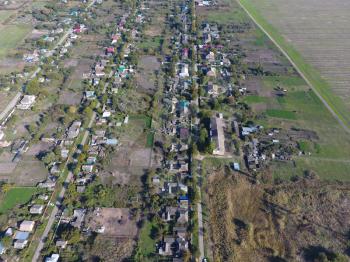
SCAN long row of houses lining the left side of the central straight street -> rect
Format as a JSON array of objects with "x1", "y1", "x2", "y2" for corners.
[{"x1": 152, "y1": 4, "x2": 192, "y2": 261}]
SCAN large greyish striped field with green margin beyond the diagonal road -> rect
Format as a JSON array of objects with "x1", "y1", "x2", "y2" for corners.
[{"x1": 239, "y1": 0, "x2": 350, "y2": 130}]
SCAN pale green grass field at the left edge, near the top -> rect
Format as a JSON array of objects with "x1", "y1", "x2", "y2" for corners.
[{"x1": 0, "y1": 25, "x2": 31, "y2": 58}]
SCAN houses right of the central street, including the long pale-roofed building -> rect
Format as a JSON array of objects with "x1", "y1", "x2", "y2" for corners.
[{"x1": 194, "y1": 15, "x2": 304, "y2": 170}]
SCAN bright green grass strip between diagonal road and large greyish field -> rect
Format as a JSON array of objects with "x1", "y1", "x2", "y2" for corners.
[{"x1": 237, "y1": 0, "x2": 350, "y2": 129}]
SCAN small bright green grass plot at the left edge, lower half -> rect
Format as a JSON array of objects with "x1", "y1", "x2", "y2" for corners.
[{"x1": 0, "y1": 187, "x2": 37, "y2": 213}]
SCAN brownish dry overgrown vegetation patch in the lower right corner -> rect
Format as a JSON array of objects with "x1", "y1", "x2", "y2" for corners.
[{"x1": 208, "y1": 173, "x2": 350, "y2": 261}]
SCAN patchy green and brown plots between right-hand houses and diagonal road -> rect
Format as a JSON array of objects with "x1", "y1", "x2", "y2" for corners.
[{"x1": 199, "y1": 0, "x2": 350, "y2": 181}]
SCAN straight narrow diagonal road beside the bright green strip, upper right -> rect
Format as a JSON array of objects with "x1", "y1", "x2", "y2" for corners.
[{"x1": 237, "y1": 0, "x2": 350, "y2": 133}]
